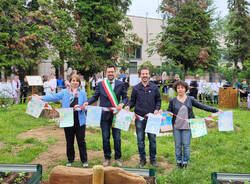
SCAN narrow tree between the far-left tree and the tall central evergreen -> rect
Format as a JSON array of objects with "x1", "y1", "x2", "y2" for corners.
[{"x1": 41, "y1": 0, "x2": 76, "y2": 75}]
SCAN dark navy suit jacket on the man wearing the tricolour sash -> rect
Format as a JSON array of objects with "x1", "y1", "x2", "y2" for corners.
[{"x1": 88, "y1": 80, "x2": 128, "y2": 121}]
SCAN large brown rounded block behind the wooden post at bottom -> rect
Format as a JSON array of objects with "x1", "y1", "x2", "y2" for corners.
[{"x1": 49, "y1": 166, "x2": 146, "y2": 184}]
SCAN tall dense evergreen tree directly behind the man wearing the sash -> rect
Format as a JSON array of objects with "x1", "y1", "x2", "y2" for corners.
[{"x1": 69, "y1": 0, "x2": 132, "y2": 78}]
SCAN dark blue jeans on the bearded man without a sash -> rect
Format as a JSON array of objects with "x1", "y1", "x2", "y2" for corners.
[{"x1": 135, "y1": 119, "x2": 156, "y2": 161}]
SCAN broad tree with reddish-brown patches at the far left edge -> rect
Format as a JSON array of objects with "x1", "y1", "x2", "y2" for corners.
[{"x1": 0, "y1": 0, "x2": 50, "y2": 77}]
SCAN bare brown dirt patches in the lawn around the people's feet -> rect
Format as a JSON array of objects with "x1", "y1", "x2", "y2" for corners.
[{"x1": 18, "y1": 125, "x2": 174, "y2": 174}]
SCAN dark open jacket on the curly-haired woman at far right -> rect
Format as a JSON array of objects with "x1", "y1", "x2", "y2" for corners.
[{"x1": 167, "y1": 96, "x2": 219, "y2": 124}]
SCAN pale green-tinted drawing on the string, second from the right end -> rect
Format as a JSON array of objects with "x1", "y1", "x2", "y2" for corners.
[{"x1": 189, "y1": 119, "x2": 207, "y2": 138}]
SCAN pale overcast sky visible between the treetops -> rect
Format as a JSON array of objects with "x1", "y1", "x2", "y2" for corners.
[{"x1": 128, "y1": 0, "x2": 228, "y2": 18}]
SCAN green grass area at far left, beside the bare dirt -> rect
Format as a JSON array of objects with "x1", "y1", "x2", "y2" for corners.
[{"x1": 0, "y1": 105, "x2": 55, "y2": 163}]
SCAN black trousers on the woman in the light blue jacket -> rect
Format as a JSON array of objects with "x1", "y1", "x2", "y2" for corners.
[{"x1": 64, "y1": 122, "x2": 88, "y2": 163}]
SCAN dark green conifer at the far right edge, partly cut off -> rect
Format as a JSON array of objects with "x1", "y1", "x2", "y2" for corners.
[{"x1": 225, "y1": 0, "x2": 250, "y2": 70}]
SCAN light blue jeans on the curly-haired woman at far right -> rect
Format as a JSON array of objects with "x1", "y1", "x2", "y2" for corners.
[{"x1": 174, "y1": 128, "x2": 191, "y2": 163}]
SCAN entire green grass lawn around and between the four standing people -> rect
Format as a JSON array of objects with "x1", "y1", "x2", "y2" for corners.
[{"x1": 0, "y1": 103, "x2": 250, "y2": 184}]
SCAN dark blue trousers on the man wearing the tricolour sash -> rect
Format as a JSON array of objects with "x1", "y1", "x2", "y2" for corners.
[{"x1": 101, "y1": 121, "x2": 121, "y2": 160}]
